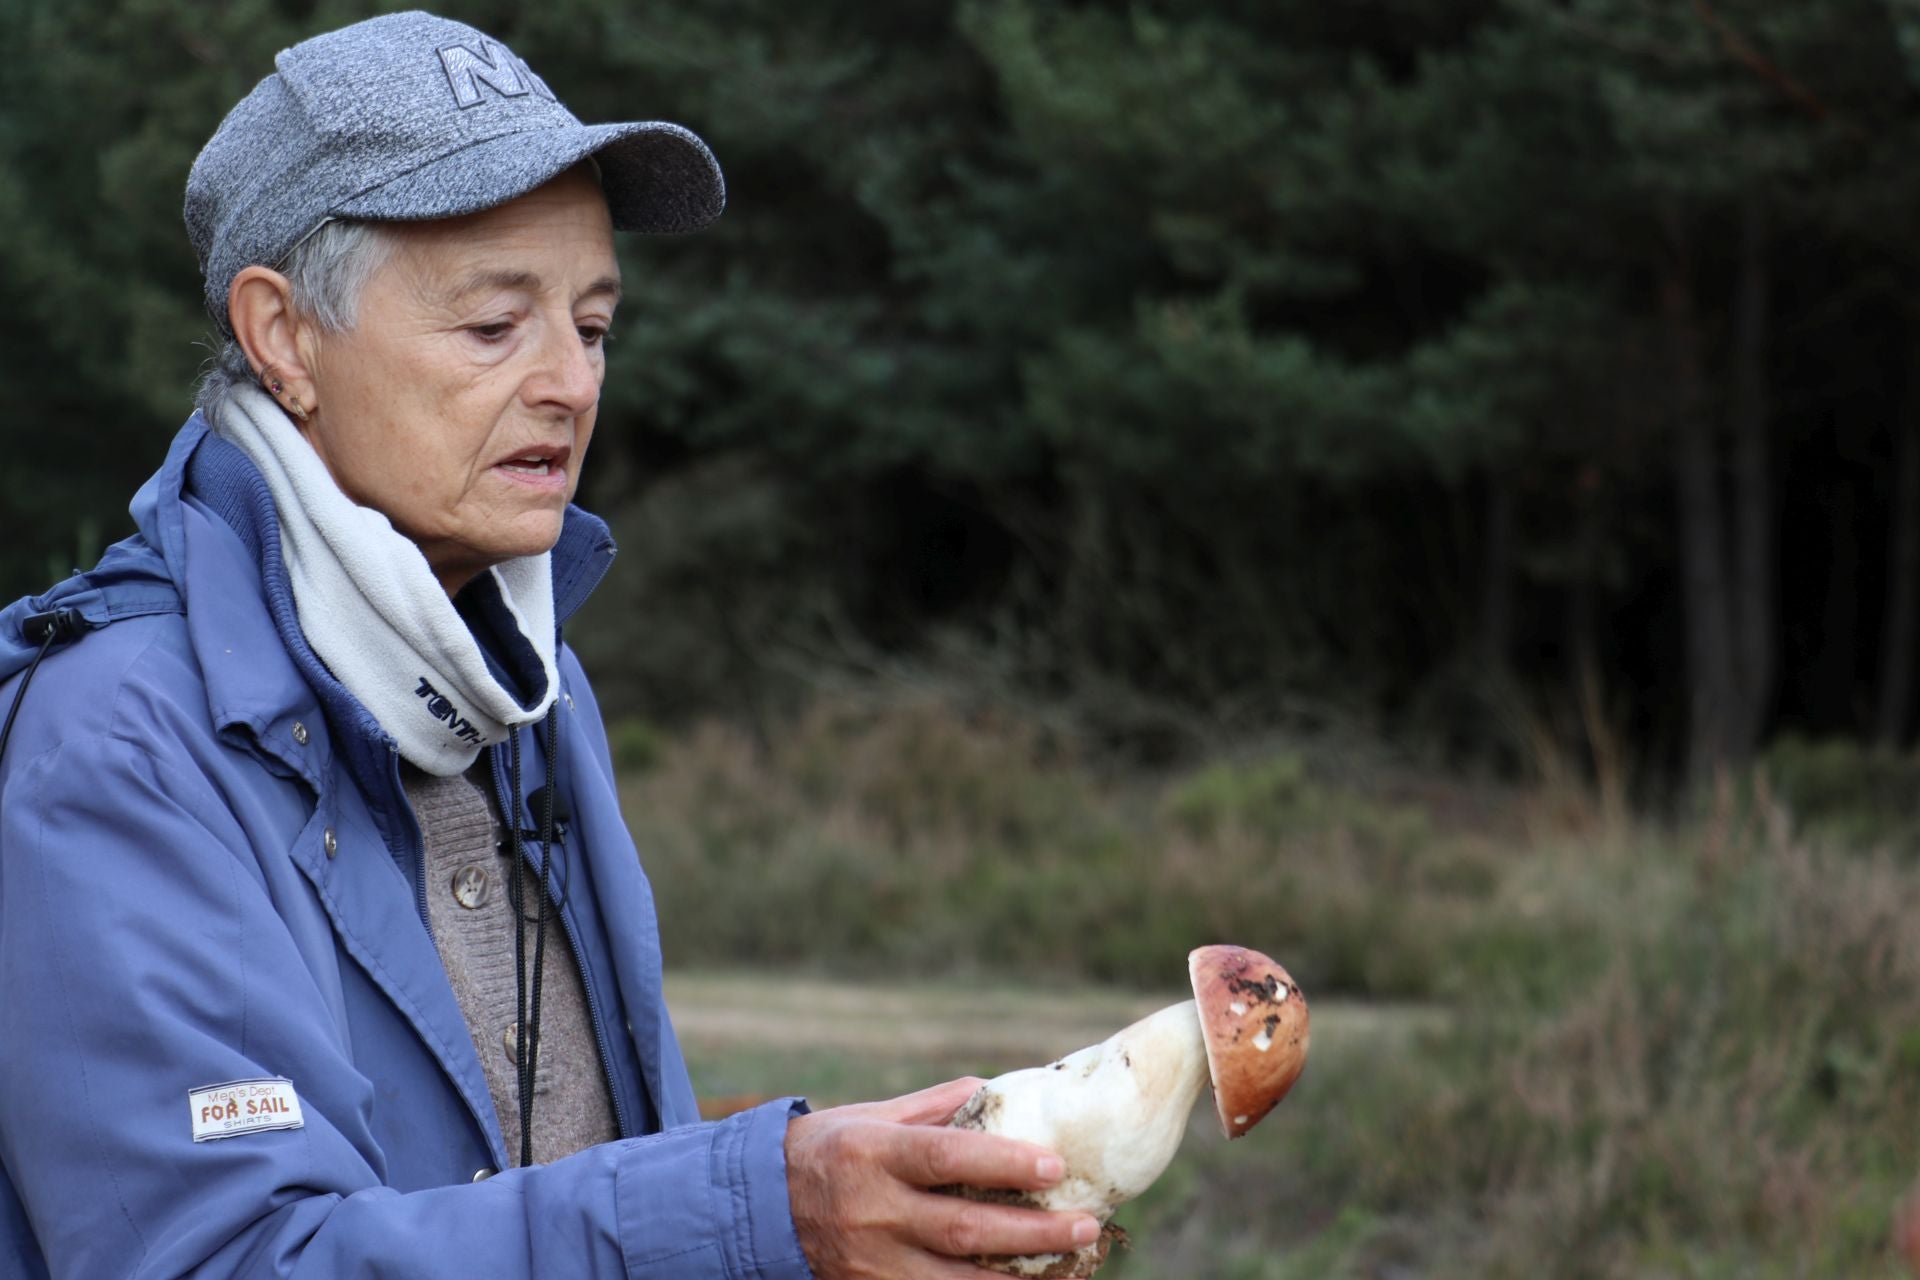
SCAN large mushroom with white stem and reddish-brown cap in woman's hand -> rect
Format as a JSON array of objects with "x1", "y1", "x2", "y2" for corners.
[{"x1": 948, "y1": 946, "x2": 1308, "y2": 1280}]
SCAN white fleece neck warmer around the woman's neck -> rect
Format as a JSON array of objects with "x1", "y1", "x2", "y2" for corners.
[{"x1": 213, "y1": 386, "x2": 559, "y2": 777}]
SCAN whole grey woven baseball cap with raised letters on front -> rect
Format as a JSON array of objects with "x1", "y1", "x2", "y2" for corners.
[{"x1": 186, "y1": 12, "x2": 726, "y2": 330}]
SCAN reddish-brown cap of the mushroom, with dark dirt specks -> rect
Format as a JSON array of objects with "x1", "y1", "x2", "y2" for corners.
[{"x1": 1187, "y1": 946, "x2": 1308, "y2": 1138}]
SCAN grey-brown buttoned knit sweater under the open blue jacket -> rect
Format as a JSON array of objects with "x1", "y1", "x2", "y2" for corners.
[{"x1": 401, "y1": 756, "x2": 620, "y2": 1165}]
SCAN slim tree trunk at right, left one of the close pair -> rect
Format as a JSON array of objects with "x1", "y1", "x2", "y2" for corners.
[{"x1": 1661, "y1": 215, "x2": 1736, "y2": 787}]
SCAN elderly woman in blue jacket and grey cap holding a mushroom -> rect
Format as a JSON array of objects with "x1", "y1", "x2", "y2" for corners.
[{"x1": 0, "y1": 13, "x2": 1096, "y2": 1280}]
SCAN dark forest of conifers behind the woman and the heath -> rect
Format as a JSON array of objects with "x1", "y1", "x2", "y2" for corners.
[{"x1": 0, "y1": 0, "x2": 1920, "y2": 791}]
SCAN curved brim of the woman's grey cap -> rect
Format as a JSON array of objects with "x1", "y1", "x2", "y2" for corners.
[{"x1": 332, "y1": 121, "x2": 726, "y2": 232}]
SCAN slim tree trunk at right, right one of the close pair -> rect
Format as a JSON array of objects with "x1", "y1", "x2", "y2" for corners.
[{"x1": 1726, "y1": 200, "x2": 1778, "y2": 764}]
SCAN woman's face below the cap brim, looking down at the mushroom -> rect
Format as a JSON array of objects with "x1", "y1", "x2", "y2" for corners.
[{"x1": 301, "y1": 169, "x2": 620, "y2": 593}]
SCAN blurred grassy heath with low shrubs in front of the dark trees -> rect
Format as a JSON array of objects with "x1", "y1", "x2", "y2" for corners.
[{"x1": 626, "y1": 704, "x2": 1920, "y2": 1280}]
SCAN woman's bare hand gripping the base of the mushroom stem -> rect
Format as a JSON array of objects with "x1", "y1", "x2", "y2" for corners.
[{"x1": 787, "y1": 1080, "x2": 1100, "y2": 1280}]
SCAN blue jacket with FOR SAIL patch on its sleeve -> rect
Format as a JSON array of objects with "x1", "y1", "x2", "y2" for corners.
[{"x1": 0, "y1": 416, "x2": 810, "y2": 1280}]
